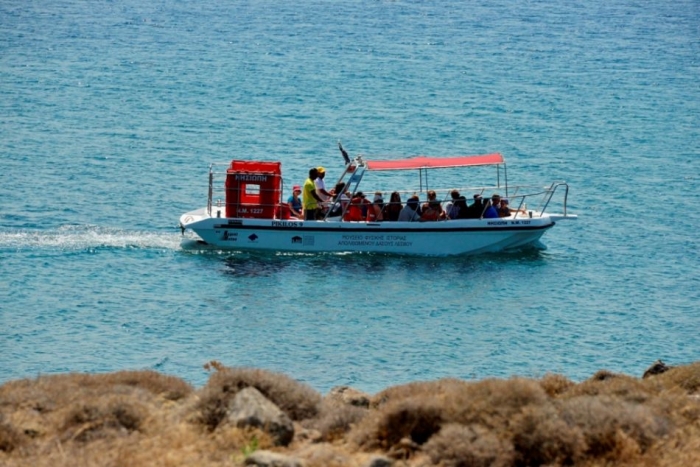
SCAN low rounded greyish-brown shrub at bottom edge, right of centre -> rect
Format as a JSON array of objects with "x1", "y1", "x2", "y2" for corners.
[{"x1": 423, "y1": 423, "x2": 514, "y2": 467}]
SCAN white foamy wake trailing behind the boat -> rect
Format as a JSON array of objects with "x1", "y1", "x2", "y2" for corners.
[{"x1": 0, "y1": 225, "x2": 181, "y2": 251}]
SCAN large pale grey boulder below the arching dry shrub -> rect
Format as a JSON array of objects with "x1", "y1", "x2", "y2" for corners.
[{"x1": 227, "y1": 387, "x2": 294, "y2": 446}]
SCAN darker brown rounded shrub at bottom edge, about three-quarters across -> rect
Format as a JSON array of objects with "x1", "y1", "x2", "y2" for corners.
[{"x1": 511, "y1": 405, "x2": 586, "y2": 466}]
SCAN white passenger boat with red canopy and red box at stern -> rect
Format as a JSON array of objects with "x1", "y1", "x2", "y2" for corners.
[{"x1": 180, "y1": 143, "x2": 577, "y2": 256}]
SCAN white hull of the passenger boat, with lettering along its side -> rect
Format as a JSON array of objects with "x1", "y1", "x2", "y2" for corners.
[{"x1": 180, "y1": 209, "x2": 554, "y2": 256}]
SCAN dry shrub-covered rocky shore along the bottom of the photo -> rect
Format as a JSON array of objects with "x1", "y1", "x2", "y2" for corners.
[{"x1": 0, "y1": 362, "x2": 700, "y2": 467}]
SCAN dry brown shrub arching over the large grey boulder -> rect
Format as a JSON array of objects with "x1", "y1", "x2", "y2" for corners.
[{"x1": 197, "y1": 364, "x2": 321, "y2": 430}]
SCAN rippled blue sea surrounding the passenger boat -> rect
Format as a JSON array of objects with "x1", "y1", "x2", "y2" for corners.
[{"x1": 0, "y1": 0, "x2": 700, "y2": 392}]
